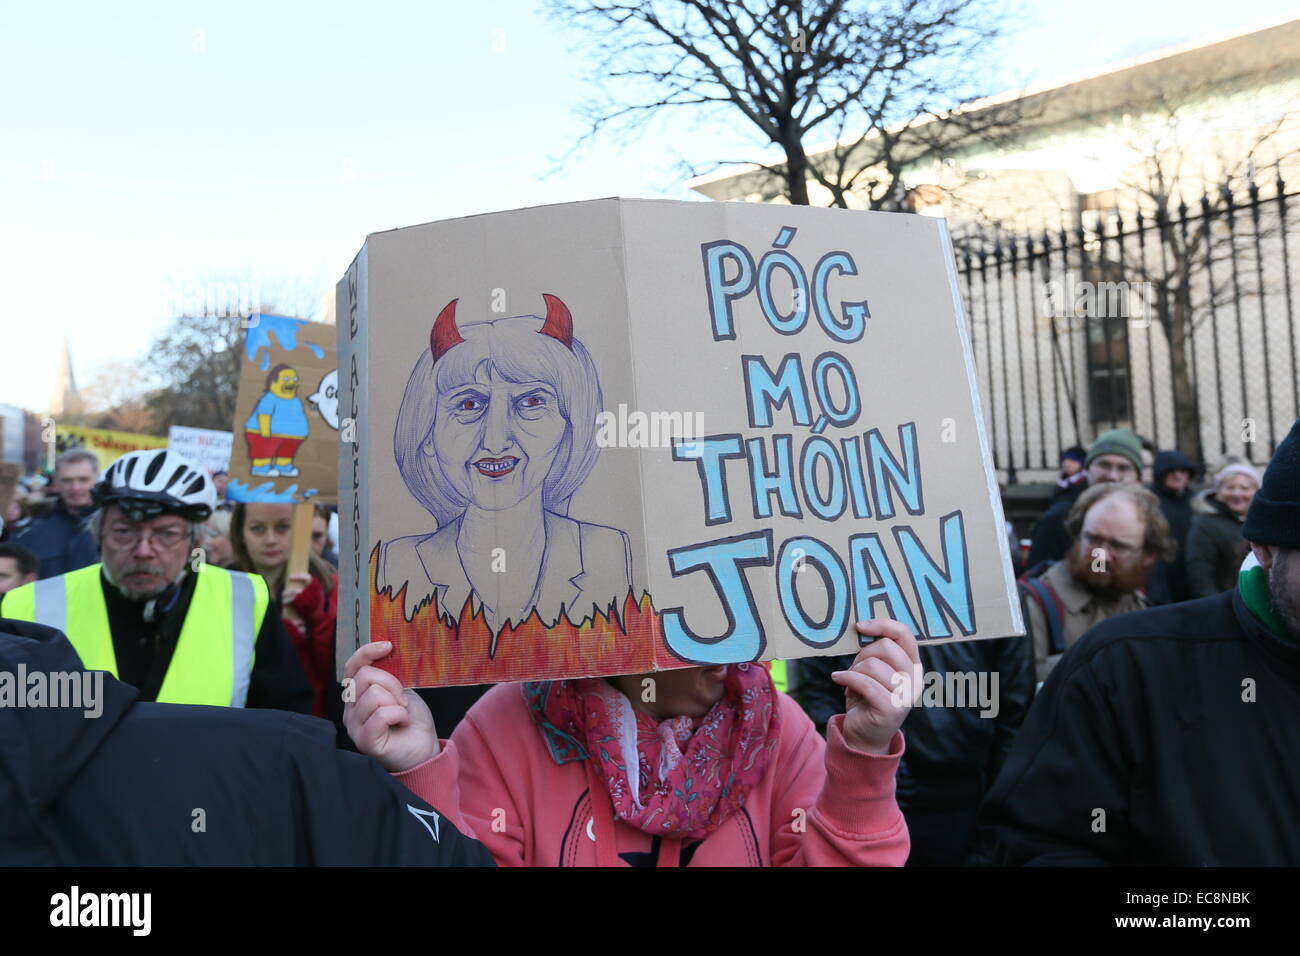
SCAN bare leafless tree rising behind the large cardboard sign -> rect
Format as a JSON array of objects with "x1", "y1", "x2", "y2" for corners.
[{"x1": 547, "y1": 0, "x2": 1021, "y2": 208}]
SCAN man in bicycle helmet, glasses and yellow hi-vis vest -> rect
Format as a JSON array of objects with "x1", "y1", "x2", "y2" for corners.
[{"x1": 0, "y1": 449, "x2": 312, "y2": 714}]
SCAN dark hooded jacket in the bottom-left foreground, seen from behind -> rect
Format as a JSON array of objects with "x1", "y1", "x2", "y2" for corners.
[{"x1": 0, "y1": 620, "x2": 493, "y2": 866}]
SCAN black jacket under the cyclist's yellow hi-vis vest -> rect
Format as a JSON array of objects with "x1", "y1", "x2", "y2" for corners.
[{"x1": 0, "y1": 572, "x2": 312, "y2": 714}]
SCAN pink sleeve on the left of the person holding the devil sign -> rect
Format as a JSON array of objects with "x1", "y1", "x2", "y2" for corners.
[{"x1": 394, "y1": 713, "x2": 528, "y2": 866}]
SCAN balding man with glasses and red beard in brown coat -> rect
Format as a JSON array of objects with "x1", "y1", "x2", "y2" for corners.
[{"x1": 1021, "y1": 483, "x2": 1173, "y2": 682}]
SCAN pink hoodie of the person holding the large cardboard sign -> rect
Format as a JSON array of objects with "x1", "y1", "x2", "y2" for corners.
[{"x1": 394, "y1": 684, "x2": 910, "y2": 866}]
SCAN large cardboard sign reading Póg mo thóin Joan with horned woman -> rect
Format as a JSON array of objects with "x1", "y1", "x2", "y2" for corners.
[{"x1": 337, "y1": 199, "x2": 1023, "y2": 685}]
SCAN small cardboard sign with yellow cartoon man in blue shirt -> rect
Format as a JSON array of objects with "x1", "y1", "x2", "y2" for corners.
[{"x1": 226, "y1": 315, "x2": 338, "y2": 503}]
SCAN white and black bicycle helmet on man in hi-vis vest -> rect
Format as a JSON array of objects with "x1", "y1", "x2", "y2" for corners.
[{"x1": 91, "y1": 449, "x2": 217, "y2": 522}]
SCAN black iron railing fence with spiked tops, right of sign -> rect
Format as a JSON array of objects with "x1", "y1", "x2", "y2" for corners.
[{"x1": 954, "y1": 173, "x2": 1300, "y2": 484}]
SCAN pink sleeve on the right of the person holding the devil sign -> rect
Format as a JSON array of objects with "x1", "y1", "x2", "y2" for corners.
[{"x1": 772, "y1": 714, "x2": 911, "y2": 866}]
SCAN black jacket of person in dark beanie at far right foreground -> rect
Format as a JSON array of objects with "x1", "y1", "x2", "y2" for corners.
[{"x1": 980, "y1": 591, "x2": 1300, "y2": 866}]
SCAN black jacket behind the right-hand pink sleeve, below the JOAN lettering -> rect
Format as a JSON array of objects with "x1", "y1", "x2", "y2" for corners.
[{"x1": 796, "y1": 637, "x2": 1034, "y2": 813}]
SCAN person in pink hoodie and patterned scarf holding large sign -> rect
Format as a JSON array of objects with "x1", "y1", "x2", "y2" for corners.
[{"x1": 343, "y1": 619, "x2": 920, "y2": 866}]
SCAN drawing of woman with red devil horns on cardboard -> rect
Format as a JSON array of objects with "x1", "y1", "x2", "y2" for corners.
[{"x1": 376, "y1": 294, "x2": 632, "y2": 647}]
